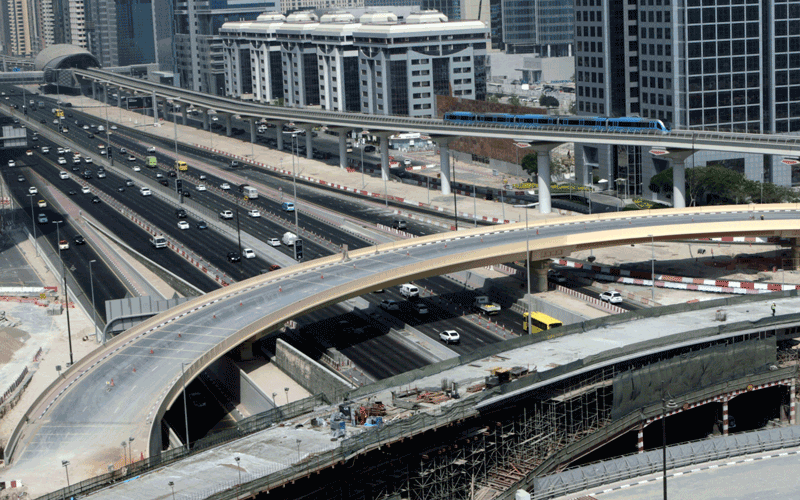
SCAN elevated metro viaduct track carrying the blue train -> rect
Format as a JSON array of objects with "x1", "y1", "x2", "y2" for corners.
[{"x1": 74, "y1": 69, "x2": 800, "y2": 156}]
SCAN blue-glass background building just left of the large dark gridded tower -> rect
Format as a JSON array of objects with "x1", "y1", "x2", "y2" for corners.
[{"x1": 500, "y1": 0, "x2": 576, "y2": 57}]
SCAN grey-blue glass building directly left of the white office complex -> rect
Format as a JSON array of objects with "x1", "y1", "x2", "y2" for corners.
[{"x1": 174, "y1": 0, "x2": 281, "y2": 95}]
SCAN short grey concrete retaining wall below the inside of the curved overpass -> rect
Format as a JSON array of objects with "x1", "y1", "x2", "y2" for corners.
[{"x1": 272, "y1": 339, "x2": 351, "y2": 401}]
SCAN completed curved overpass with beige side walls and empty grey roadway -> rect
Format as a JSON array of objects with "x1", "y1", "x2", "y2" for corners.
[{"x1": 6, "y1": 204, "x2": 800, "y2": 479}]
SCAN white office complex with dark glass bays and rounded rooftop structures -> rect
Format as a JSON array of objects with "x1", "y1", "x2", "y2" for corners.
[{"x1": 221, "y1": 11, "x2": 489, "y2": 117}]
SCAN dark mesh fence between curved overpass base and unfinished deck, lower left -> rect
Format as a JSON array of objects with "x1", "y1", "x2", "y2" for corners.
[{"x1": 37, "y1": 395, "x2": 328, "y2": 500}]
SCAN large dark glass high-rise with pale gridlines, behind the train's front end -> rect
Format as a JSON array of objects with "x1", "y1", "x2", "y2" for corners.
[{"x1": 575, "y1": 0, "x2": 800, "y2": 196}]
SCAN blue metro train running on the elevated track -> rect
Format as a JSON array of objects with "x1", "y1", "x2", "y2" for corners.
[{"x1": 444, "y1": 111, "x2": 669, "y2": 134}]
